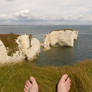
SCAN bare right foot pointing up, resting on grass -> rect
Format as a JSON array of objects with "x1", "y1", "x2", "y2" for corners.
[{"x1": 57, "y1": 74, "x2": 71, "y2": 92}]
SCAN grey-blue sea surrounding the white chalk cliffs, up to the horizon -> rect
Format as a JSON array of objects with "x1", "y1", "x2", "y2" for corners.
[{"x1": 0, "y1": 25, "x2": 92, "y2": 66}]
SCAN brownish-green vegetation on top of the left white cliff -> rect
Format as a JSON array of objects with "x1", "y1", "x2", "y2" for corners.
[{"x1": 0, "y1": 33, "x2": 19, "y2": 55}]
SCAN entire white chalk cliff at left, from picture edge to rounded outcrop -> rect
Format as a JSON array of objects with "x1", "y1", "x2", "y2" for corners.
[{"x1": 0, "y1": 35, "x2": 40, "y2": 63}]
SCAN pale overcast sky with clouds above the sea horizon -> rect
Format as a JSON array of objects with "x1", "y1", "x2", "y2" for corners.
[{"x1": 0, "y1": 0, "x2": 92, "y2": 24}]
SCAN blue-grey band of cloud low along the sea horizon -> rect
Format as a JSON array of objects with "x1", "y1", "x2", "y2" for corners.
[{"x1": 0, "y1": 16, "x2": 92, "y2": 25}]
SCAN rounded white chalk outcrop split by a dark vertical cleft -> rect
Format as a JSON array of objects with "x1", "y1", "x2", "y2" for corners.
[{"x1": 16, "y1": 35, "x2": 40, "y2": 60}]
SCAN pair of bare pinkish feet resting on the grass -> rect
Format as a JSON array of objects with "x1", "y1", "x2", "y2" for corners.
[{"x1": 24, "y1": 74, "x2": 71, "y2": 92}]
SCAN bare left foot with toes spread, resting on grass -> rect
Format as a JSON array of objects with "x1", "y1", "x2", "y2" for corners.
[{"x1": 24, "y1": 77, "x2": 39, "y2": 92}]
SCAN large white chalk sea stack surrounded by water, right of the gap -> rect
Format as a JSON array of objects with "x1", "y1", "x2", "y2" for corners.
[{"x1": 43, "y1": 30, "x2": 78, "y2": 50}]
